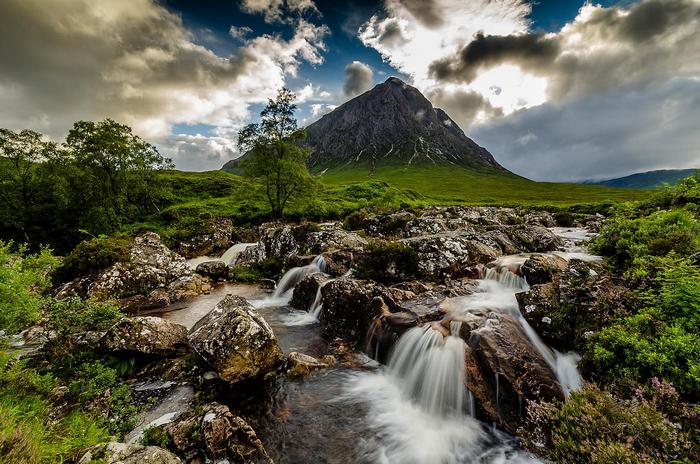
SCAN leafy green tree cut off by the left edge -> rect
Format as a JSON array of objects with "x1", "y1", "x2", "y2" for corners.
[{"x1": 0, "y1": 129, "x2": 56, "y2": 243}]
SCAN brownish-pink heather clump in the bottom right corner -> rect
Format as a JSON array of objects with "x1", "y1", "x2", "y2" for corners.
[{"x1": 520, "y1": 385, "x2": 700, "y2": 464}]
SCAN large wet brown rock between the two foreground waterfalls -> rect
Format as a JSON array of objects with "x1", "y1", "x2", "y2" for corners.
[{"x1": 460, "y1": 312, "x2": 564, "y2": 433}]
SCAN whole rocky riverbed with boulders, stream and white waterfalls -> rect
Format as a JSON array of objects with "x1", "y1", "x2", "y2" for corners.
[{"x1": 38, "y1": 207, "x2": 622, "y2": 463}]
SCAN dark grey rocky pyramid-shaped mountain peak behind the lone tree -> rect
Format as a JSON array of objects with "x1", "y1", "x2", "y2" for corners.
[{"x1": 223, "y1": 77, "x2": 510, "y2": 174}]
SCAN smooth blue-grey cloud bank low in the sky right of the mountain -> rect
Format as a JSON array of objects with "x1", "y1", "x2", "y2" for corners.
[{"x1": 470, "y1": 78, "x2": 700, "y2": 181}]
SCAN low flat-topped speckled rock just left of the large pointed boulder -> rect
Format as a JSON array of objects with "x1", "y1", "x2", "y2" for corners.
[{"x1": 99, "y1": 316, "x2": 187, "y2": 356}]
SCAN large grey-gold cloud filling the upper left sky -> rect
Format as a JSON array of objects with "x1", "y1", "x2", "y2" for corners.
[{"x1": 0, "y1": 0, "x2": 328, "y2": 168}]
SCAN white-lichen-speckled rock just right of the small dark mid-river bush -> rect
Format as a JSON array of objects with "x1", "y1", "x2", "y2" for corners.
[{"x1": 405, "y1": 232, "x2": 501, "y2": 278}]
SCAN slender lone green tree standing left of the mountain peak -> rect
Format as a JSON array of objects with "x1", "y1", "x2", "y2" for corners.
[{"x1": 238, "y1": 88, "x2": 311, "y2": 219}]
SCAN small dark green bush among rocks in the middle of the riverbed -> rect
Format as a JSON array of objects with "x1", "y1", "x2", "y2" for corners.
[{"x1": 355, "y1": 240, "x2": 418, "y2": 284}]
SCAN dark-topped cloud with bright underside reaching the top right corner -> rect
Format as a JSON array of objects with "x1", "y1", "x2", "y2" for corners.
[{"x1": 430, "y1": 0, "x2": 700, "y2": 99}]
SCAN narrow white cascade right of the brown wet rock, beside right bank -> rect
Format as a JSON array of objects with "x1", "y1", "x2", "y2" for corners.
[{"x1": 480, "y1": 268, "x2": 583, "y2": 396}]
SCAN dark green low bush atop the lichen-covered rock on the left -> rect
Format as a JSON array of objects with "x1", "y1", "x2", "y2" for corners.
[{"x1": 54, "y1": 236, "x2": 131, "y2": 283}]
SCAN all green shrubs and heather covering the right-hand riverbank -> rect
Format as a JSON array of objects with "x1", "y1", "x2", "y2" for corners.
[{"x1": 523, "y1": 176, "x2": 700, "y2": 464}]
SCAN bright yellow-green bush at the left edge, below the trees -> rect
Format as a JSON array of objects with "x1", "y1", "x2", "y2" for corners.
[{"x1": 0, "y1": 241, "x2": 58, "y2": 333}]
